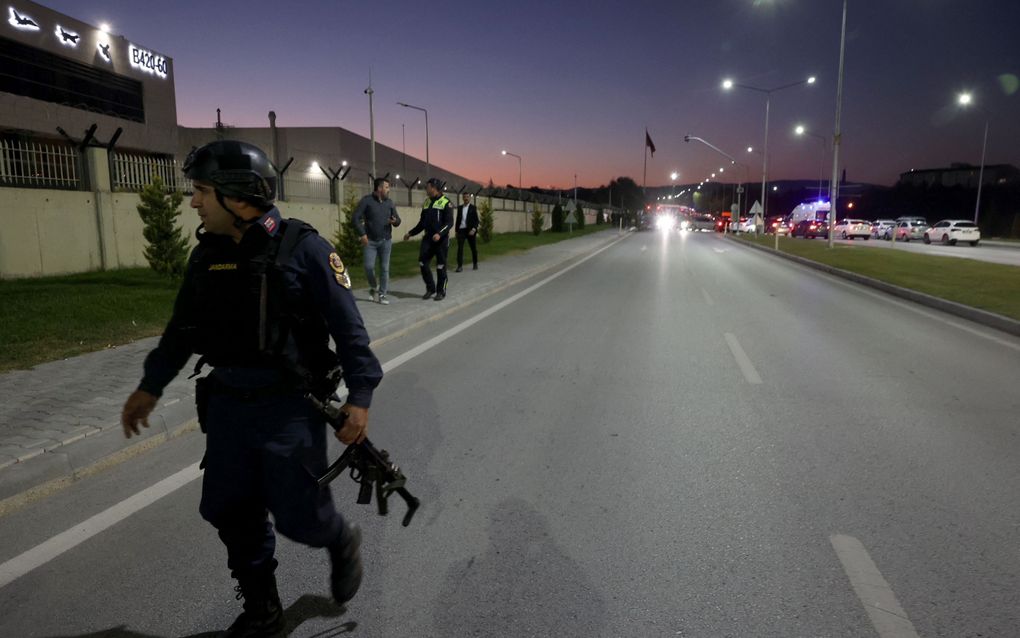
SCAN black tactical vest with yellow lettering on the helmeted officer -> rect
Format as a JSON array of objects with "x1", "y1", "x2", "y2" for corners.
[{"x1": 192, "y1": 219, "x2": 337, "y2": 387}]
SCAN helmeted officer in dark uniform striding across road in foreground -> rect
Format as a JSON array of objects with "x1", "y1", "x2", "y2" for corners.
[{"x1": 121, "y1": 141, "x2": 383, "y2": 637}]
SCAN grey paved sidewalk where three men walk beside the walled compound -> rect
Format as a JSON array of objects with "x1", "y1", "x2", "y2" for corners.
[{"x1": 0, "y1": 229, "x2": 619, "y2": 508}]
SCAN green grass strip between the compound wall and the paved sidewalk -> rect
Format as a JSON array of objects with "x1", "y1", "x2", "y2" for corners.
[{"x1": 0, "y1": 225, "x2": 609, "y2": 373}]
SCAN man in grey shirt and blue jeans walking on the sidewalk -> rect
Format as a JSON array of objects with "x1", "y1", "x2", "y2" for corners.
[{"x1": 354, "y1": 178, "x2": 400, "y2": 305}]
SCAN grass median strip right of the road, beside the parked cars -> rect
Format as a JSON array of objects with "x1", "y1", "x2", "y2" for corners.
[{"x1": 741, "y1": 235, "x2": 1020, "y2": 321}]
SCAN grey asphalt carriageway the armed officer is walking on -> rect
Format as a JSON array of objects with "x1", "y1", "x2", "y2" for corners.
[{"x1": 0, "y1": 233, "x2": 1020, "y2": 638}]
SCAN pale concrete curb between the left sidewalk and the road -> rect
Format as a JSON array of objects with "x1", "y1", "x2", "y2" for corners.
[{"x1": 0, "y1": 229, "x2": 627, "y2": 517}]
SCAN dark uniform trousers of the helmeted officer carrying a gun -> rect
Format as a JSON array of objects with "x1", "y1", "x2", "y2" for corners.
[{"x1": 199, "y1": 379, "x2": 344, "y2": 578}]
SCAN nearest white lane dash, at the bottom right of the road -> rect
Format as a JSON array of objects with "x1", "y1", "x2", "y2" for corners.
[{"x1": 829, "y1": 534, "x2": 919, "y2": 638}]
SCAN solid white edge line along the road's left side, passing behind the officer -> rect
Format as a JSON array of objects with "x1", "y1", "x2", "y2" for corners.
[{"x1": 0, "y1": 240, "x2": 619, "y2": 588}]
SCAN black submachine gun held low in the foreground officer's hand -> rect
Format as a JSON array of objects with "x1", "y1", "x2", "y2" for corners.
[{"x1": 306, "y1": 385, "x2": 421, "y2": 527}]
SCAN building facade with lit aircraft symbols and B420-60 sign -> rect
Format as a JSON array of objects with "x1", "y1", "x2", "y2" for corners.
[{"x1": 0, "y1": 0, "x2": 177, "y2": 155}]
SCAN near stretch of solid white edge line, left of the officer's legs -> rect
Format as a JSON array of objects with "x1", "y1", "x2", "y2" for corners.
[{"x1": 0, "y1": 463, "x2": 202, "y2": 587}]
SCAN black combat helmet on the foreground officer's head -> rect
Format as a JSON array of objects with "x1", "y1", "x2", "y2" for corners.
[{"x1": 184, "y1": 140, "x2": 276, "y2": 206}]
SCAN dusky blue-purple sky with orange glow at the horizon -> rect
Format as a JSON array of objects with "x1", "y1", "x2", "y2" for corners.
[{"x1": 43, "y1": 0, "x2": 1020, "y2": 187}]
